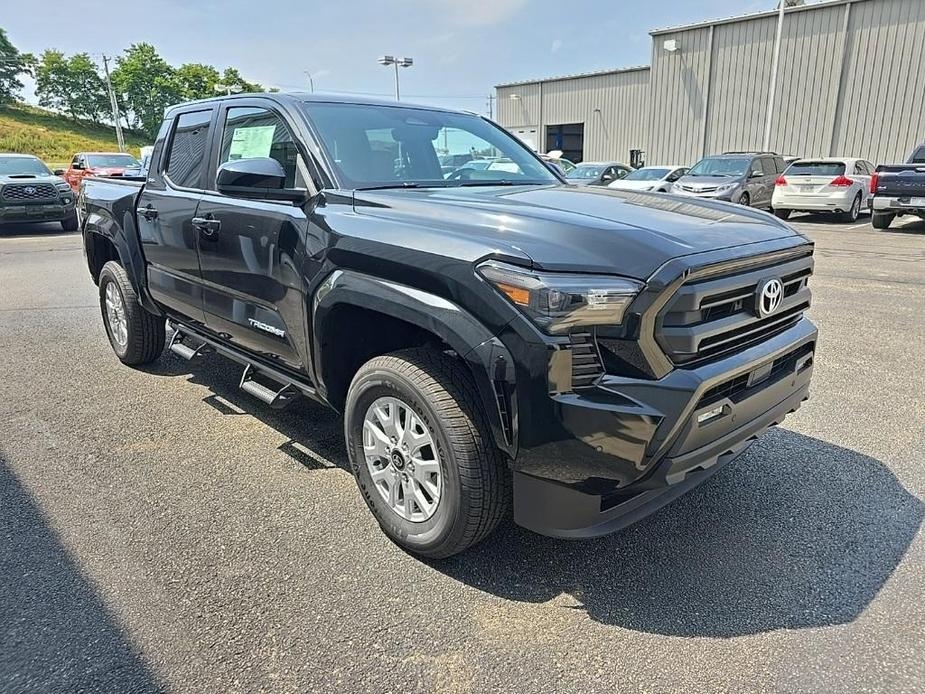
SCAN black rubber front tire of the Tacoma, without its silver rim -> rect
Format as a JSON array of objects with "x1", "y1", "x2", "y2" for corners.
[{"x1": 344, "y1": 348, "x2": 511, "y2": 559}]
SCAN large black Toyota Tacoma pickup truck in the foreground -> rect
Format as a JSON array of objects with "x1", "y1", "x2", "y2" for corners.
[{"x1": 80, "y1": 94, "x2": 816, "y2": 557}]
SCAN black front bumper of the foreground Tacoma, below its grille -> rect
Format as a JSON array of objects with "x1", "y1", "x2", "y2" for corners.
[{"x1": 514, "y1": 318, "x2": 817, "y2": 538}]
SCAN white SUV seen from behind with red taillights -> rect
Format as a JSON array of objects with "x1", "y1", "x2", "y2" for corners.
[{"x1": 771, "y1": 157, "x2": 876, "y2": 222}]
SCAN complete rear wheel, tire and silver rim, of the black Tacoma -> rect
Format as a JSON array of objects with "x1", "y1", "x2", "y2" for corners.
[{"x1": 100, "y1": 260, "x2": 166, "y2": 366}]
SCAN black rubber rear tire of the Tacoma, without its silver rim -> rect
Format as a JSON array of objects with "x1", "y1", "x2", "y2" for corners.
[{"x1": 99, "y1": 260, "x2": 166, "y2": 366}]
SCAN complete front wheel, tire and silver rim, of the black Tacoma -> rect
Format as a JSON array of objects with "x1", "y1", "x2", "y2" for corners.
[{"x1": 344, "y1": 349, "x2": 510, "y2": 559}]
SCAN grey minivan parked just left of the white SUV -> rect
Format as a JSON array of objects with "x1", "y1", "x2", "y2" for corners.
[{"x1": 671, "y1": 152, "x2": 787, "y2": 208}]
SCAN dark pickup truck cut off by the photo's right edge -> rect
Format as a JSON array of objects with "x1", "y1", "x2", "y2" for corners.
[{"x1": 868, "y1": 144, "x2": 925, "y2": 229}]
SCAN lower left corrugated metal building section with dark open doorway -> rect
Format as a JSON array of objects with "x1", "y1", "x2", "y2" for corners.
[{"x1": 498, "y1": 68, "x2": 649, "y2": 161}]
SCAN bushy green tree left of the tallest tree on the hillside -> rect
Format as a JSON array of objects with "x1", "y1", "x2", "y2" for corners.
[{"x1": 35, "y1": 49, "x2": 109, "y2": 121}]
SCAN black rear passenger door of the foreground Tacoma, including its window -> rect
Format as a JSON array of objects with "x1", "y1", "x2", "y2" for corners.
[{"x1": 137, "y1": 105, "x2": 216, "y2": 323}]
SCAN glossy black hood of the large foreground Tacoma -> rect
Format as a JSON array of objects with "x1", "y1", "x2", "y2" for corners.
[{"x1": 354, "y1": 185, "x2": 805, "y2": 279}]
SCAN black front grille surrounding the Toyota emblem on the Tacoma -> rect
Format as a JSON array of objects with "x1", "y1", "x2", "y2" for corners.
[{"x1": 657, "y1": 250, "x2": 813, "y2": 365}]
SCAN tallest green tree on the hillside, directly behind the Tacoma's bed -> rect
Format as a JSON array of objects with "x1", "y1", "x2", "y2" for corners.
[{"x1": 111, "y1": 43, "x2": 186, "y2": 138}]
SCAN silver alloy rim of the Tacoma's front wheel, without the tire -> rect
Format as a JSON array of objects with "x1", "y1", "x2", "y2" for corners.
[{"x1": 363, "y1": 397, "x2": 443, "y2": 523}]
